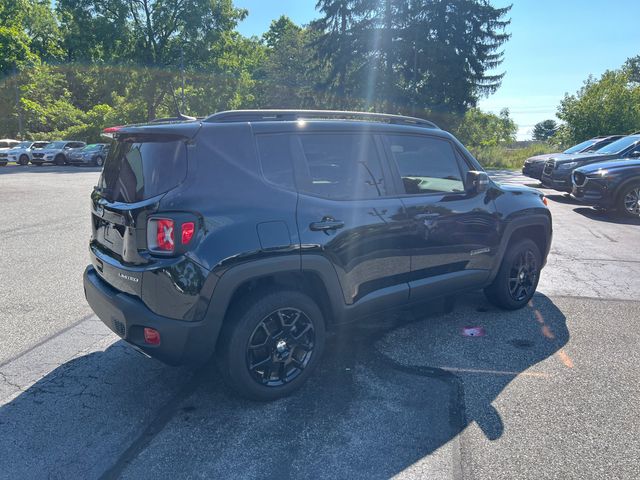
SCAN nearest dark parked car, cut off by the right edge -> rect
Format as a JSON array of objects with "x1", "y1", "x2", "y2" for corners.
[{"x1": 571, "y1": 159, "x2": 640, "y2": 218}]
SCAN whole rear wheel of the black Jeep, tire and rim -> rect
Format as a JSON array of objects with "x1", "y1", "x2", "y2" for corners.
[{"x1": 217, "y1": 291, "x2": 326, "y2": 401}]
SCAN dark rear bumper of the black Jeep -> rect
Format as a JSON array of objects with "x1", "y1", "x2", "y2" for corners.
[{"x1": 84, "y1": 266, "x2": 219, "y2": 365}]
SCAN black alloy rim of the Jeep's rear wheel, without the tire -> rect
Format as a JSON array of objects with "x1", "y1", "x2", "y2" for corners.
[{"x1": 246, "y1": 308, "x2": 315, "y2": 387}]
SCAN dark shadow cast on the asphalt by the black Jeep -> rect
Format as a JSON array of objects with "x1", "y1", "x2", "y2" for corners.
[{"x1": 0, "y1": 293, "x2": 569, "y2": 478}]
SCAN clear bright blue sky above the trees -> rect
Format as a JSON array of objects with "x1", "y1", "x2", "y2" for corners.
[{"x1": 234, "y1": 0, "x2": 640, "y2": 139}]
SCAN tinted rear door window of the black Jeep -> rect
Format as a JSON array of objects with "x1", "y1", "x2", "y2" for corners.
[{"x1": 296, "y1": 134, "x2": 386, "y2": 200}]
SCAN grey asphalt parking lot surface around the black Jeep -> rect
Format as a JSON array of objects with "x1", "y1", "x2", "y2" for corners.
[{"x1": 0, "y1": 166, "x2": 640, "y2": 480}]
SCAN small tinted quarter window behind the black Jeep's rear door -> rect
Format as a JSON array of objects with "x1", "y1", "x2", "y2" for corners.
[{"x1": 256, "y1": 135, "x2": 295, "y2": 190}]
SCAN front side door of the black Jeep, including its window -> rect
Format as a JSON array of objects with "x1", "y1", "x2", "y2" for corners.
[{"x1": 382, "y1": 134, "x2": 499, "y2": 298}]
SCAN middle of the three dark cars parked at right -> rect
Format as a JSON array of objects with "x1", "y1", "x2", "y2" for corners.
[{"x1": 542, "y1": 134, "x2": 640, "y2": 193}]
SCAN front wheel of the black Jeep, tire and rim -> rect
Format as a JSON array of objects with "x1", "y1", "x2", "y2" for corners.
[{"x1": 484, "y1": 239, "x2": 542, "y2": 310}]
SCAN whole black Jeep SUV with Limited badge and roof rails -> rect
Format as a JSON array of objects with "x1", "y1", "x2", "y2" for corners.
[{"x1": 84, "y1": 111, "x2": 551, "y2": 400}]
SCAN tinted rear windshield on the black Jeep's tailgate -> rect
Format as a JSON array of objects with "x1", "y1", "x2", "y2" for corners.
[{"x1": 98, "y1": 136, "x2": 187, "y2": 203}]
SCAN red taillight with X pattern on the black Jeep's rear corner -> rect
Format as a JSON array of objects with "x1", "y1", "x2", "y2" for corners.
[{"x1": 147, "y1": 217, "x2": 197, "y2": 255}]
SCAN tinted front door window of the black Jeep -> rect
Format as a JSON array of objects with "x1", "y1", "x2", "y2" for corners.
[{"x1": 387, "y1": 135, "x2": 464, "y2": 194}]
